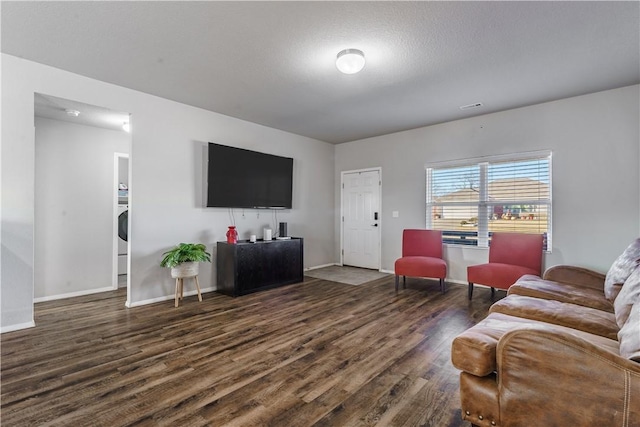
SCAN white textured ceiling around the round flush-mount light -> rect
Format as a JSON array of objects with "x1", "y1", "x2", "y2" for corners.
[{"x1": 1, "y1": 1, "x2": 640, "y2": 143}]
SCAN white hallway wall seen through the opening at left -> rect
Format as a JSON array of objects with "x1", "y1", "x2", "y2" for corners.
[{"x1": 34, "y1": 117, "x2": 131, "y2": 299}]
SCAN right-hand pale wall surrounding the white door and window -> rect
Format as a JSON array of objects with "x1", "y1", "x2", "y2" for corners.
[{"x1": 335, "y1": 85, "x2": 640, "y2": 282}]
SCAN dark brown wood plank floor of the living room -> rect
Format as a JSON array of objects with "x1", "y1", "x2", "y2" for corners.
[{"x1": 1, "y1": 276, "x2": 498, "y2": 427}]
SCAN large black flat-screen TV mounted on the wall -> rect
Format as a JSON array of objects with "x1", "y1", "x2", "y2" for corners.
[{"x1": 207, "y1": 142, "x2": 293, "y2": 209}]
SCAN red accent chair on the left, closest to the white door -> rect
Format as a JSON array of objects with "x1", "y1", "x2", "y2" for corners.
[{"x1": 395, "y1": 230, "x2": 447, "y2": 293}]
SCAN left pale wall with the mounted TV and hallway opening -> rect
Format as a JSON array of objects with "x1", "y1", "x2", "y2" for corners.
[{"x1": 0, "y1": 54, "x2": 335, "y2": 331}]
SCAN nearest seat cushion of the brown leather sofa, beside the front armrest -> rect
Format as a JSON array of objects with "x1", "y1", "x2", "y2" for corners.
[{"x1": 451, "y1": 312, "x2": 619, "y2": 377}]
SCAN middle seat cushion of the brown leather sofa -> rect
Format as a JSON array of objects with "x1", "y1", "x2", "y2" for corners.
[{"x1": 489, "y1": 295, "x2": 620, "y2": 340}]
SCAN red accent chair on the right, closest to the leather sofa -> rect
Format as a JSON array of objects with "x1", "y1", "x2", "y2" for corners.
[{"x1": 467, "y1": 233, "x2": 544, "y2": 299}]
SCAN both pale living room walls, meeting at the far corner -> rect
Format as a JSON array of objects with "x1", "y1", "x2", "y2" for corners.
[{"x1": 0, "y1": 54, "x2": 640, "y2": 331}]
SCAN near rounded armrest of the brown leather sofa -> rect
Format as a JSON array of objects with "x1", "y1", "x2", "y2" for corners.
[{"x1": 496, "y1": 326, "x2": 640, "y2": 426}]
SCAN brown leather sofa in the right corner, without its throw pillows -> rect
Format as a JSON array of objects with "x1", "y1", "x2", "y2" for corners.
[{"x1": 451, "y1": 239, "x2": 640, "y2": 427}]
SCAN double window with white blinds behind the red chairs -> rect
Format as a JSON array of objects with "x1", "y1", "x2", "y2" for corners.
[{"x1": 426, "y1": 151, "x2": 551, "y2": 249}]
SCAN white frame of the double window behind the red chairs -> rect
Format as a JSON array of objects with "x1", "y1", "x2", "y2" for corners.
[{"x1": 425, "y1": 150, "x2": 553, "y2": 253}]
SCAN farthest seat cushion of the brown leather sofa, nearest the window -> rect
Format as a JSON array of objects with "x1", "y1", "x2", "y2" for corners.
[{"x1": 509, "y1": 275, "x2": 613, "y2": 312}]
